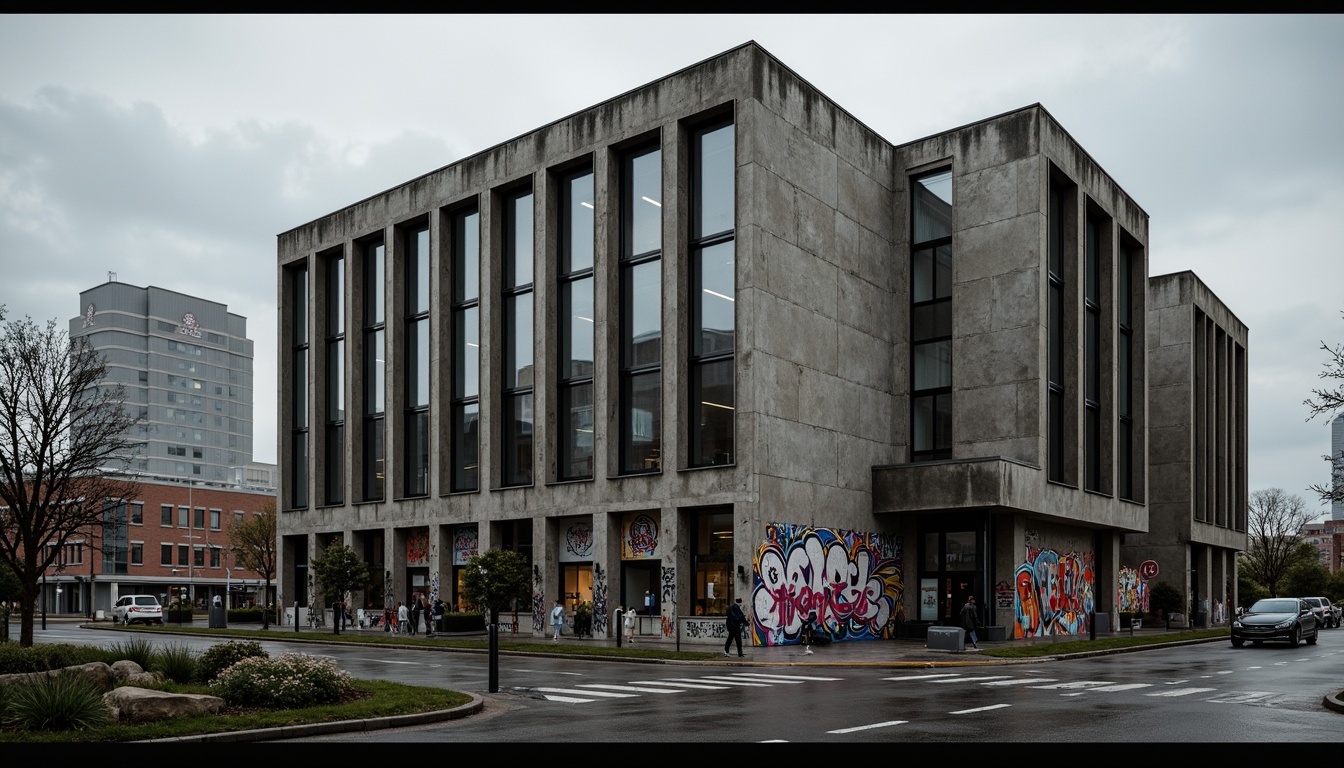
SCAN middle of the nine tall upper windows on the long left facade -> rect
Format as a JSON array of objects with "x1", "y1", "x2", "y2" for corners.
[{"x1": 452, "y1": 208, "x2": 481, "y2": 491}]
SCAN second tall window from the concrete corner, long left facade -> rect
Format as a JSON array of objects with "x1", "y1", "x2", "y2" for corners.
[{"x1": 620, "y1": 147, "x2": 663, "y2": 473}]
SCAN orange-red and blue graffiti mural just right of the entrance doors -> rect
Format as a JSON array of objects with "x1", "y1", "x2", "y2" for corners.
[{"x1": 1013, "y1": 546, "x2": 1095, "y2": 639}]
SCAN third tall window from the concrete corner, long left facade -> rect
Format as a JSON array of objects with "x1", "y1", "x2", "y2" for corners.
[{"x1": 556, "y1": 169, "x2": 594, "y2": 480}]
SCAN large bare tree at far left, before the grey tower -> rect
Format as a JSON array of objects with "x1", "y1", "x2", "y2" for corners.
[{"x1": 0, "y1": 317, "x2": 138, "y2": 646}]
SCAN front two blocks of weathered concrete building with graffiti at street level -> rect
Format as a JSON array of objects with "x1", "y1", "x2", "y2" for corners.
[{"x1": 278, "y1": 43, "x2": 1245, "y2": 644}]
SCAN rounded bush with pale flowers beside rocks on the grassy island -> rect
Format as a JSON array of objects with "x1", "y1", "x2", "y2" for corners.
[{"x1": 210, "y1": 654, "x2": 351, "y2": 709}]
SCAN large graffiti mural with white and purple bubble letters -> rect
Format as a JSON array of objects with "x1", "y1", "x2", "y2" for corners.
[{"x1": 749, "y1": 523, "x2": 905, "y2": 646}]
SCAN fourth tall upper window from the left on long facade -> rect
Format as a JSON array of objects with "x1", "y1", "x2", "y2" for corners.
[{"x1": 402, "y1": 226, "x2": 430, "y2": 496}]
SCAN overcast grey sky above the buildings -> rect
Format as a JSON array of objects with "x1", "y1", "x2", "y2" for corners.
[{"x1": 0, "y1": 15, "x2": 1344, "y2": 519}]
